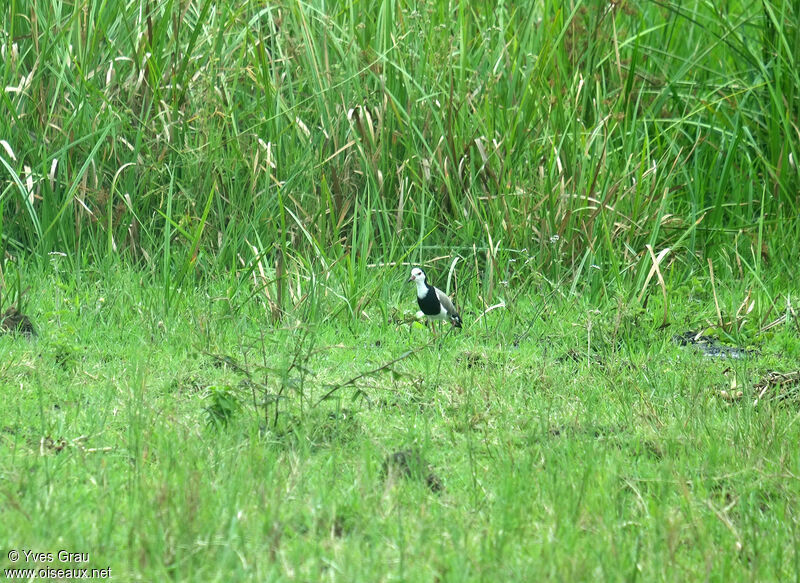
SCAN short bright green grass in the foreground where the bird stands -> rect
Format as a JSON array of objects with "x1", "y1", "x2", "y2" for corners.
[{"x1": 0, "y1": 268, "x2": 800, "y2": 581}]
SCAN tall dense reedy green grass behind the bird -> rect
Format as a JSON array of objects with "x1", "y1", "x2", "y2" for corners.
[{"x1": 0, "y1": 0, "x2": 800, "y2": 313}]
